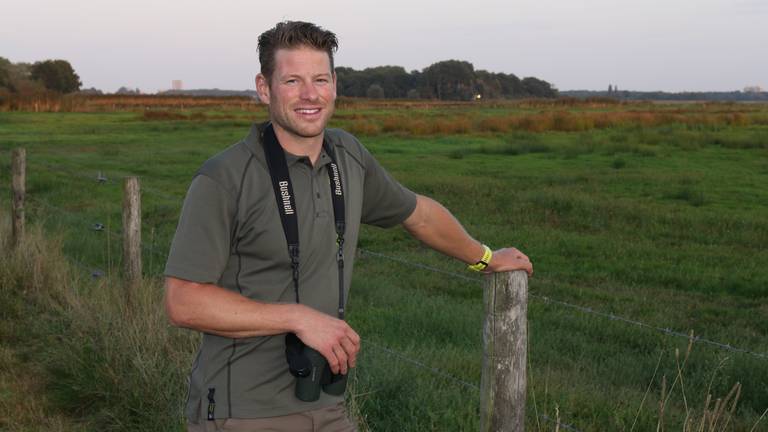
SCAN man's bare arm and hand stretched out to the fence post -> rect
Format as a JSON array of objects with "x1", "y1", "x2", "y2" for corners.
[{"x1": 403, "y1": 195, "x2": 533, "y2": 276}]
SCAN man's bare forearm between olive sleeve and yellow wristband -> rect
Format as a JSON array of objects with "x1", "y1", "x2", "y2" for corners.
[{"x1": 403, "y1": 195, "x2": 483, "y2": 264}]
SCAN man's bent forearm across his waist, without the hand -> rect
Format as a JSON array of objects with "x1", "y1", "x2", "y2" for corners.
[{"x1": 165, "y1": 278, "x2": 303, "y2": 338}]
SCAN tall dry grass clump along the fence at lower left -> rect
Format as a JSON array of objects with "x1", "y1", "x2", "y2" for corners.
[{"x1": 0, "y1": 216, "x2": 197, "y2": 431}]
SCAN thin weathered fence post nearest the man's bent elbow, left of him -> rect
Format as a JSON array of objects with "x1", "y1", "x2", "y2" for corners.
[{"x1": 123, "y1": 177, "x2": 141, "y2": 287}]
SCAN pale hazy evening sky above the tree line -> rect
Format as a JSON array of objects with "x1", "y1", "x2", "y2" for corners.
[{"x1": 0, "y1": 0, "x2": 768, "y2": 92}]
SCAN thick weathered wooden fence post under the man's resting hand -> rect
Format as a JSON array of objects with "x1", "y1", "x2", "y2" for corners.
[{"x1": 480, "y1": 271, "x2": 528, "y2": 432}]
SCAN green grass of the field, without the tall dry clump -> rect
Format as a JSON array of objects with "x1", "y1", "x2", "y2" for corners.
[{"x1": 0, "y1": 104, "x2": 768, "y2": 431}]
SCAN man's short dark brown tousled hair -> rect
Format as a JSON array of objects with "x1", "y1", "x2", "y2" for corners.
[{"x1": 259, "y1": 21, "x2": 339, "y2": 79}]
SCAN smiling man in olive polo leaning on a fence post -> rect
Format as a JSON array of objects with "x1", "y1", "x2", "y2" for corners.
[{"x1": 165, "y1": 22, "x2": 532, "y2": 431}]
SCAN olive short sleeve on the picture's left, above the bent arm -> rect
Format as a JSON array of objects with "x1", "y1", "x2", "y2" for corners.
[{"x1": 164, "y1": 174, "x2": 236, "y2": 283}]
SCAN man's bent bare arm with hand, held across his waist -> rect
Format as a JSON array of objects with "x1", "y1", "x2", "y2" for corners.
[{"x1": 165, "y1": 277, "x2": 360, "y2": 373}]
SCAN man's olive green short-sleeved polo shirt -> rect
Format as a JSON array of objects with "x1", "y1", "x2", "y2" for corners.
[{"x1": 165, "y1": 125, "x2": 416, "y2": 421}]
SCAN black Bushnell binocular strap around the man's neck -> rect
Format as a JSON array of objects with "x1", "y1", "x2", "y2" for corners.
[{"x1": 262, "y1": 123, "x2": 346, "y2": 319}]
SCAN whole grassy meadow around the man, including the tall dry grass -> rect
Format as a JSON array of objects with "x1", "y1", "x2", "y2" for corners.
[{"x1": 0, "y1": 100, "x2": 768, "y2": 431}]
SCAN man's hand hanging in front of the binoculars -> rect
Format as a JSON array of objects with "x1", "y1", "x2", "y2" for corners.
[{"x1": 295, "y1": 306, "x2": 360, "y2": 374}]
